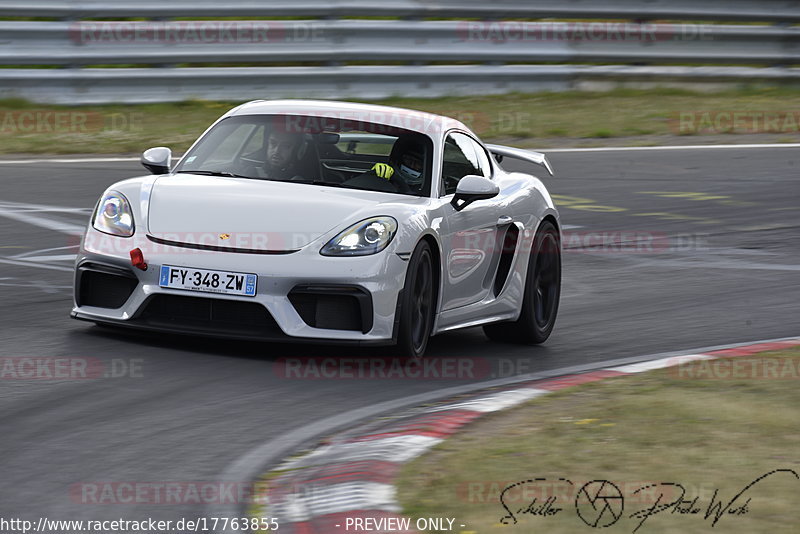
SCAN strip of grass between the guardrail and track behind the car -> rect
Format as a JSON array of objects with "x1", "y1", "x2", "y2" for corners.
[{"x1": 0, "y1": 88, "x2": 800, "y2": 154}]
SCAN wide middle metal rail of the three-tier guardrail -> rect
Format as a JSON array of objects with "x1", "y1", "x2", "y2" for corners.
[{"x1": 0, "y1": 20, "x2": 800, "y2": 66}]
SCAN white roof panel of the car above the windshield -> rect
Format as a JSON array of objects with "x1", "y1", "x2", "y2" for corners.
[{"x1": 226, "y1": 100, "x2": 475, "y2": 139}]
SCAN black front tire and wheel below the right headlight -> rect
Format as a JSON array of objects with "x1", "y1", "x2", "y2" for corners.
[{"x1": 397, "y1": 240, "x2": 436, "y2": 358}]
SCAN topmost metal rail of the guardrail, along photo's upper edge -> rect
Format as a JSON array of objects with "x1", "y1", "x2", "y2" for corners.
[{"x1": 0, "y1": 0, "x2": 800, "y2": 23}]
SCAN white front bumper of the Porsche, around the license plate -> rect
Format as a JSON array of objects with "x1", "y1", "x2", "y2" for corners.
[{"x1": 71, "y1": 228, "x2": 407, "y2": 345}]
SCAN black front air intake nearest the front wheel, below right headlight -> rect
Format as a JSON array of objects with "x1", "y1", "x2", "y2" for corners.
[{"x1": 289, "y1": 286, "x2": 372, "y2": 333}]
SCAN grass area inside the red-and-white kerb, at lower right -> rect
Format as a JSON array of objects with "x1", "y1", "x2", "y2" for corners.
[{"x1": 398, "y1": 349, "x2": 800, "y2": 534}]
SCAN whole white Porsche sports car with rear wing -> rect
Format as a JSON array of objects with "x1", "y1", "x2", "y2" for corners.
[{"x1": 72, "y1": 100, "x2": 561, "y2": 357}]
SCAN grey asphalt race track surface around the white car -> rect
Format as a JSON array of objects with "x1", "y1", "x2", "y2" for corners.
[{"x1": 0, "y1": 148, "x2": 800, "y2": 520}]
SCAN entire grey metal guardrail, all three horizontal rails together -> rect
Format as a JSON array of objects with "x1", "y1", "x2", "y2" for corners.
[{"x1": 0, "y1": 0, "x2": 800, "y2": 103}]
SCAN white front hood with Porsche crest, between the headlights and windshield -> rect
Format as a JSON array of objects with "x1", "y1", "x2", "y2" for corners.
[{"x1": 148, "y1": 174, "x2": 397, "y2": 251}]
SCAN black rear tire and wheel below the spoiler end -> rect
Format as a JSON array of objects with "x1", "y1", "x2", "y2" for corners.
[{"x1": 483, "y1": 221, "x2": 561, "y2": 344}]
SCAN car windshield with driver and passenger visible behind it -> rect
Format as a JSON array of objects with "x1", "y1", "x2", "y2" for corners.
[{"x1": 175, "y1": 115, "x2": 433, "y2": 196}]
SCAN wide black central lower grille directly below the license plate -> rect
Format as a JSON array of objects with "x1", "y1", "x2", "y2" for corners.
[{"x1": 137, "y1": 295, "x2": 283, "y2": 337}]
